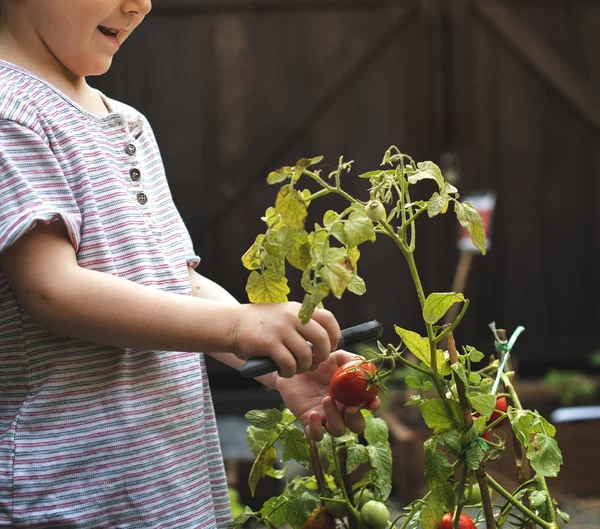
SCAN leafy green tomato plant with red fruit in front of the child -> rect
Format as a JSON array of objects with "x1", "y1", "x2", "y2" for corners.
[{"x1": 236, "y1": 146, "x2": 568, "y2": 529}]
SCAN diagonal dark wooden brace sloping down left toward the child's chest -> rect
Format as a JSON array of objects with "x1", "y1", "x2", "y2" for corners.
[{"x1": 192, "y1": 3, "x2": 418, "y2": 244}]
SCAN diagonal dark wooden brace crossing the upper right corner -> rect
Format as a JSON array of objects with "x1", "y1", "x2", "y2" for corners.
[{"x1": 472, "y1": 2, "x2": 600, "y2": 130}]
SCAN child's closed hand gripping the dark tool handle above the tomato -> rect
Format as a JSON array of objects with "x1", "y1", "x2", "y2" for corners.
[{"x1": 233, "y1": 302, "x2": 341, "y2": 378}]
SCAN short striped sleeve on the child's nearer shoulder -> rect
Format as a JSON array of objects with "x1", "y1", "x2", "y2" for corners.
[{"x1": 0, "y1": 120, "x2": 82, "y2": 253}]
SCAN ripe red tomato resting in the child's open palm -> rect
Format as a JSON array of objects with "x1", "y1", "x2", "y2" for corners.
[{"x1": 329, "y1": 359, "x2": 379, "y2": 406}]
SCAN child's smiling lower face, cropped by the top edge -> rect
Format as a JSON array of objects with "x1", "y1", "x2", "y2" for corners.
[{"x1": 13, "y1": 0, "x2": 152, "y2": 77}]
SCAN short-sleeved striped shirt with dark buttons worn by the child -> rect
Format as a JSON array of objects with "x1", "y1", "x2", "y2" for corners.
[{"x1": 0, "y1": 61, "x2": 231, "y2": 529}]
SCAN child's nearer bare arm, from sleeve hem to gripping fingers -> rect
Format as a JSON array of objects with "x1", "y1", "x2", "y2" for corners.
[{"x1": 0, "y1": 222, "x2": 339, "y2": 377}]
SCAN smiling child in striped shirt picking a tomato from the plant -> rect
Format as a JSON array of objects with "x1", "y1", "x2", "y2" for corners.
[{"x1": 0, "y1": 0, "x2": 379, "y2": 529}]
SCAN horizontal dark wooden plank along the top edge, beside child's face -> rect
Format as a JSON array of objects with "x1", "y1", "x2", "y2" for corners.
[{"x1": 152, "y1": 0, "x2": 411, "y2": 16}]
